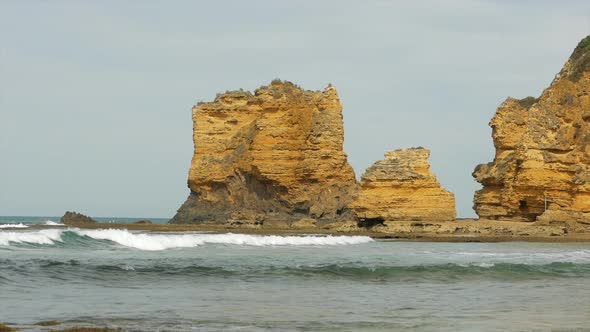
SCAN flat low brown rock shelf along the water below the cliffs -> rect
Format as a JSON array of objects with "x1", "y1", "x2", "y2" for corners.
[{"x1": 22, "y1": 219, "x2": 590, "y2": 243}]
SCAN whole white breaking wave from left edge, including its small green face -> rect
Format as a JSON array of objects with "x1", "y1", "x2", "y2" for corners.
[{"x1": 0, "y1": 228, "x2": 373, "y2": 251}]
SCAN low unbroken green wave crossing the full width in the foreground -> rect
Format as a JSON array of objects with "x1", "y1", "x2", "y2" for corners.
[{"x1": 0, "y1": 259, "x2": 590, "y2": 284}]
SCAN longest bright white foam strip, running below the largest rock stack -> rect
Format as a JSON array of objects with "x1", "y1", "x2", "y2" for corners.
[{"x1": 74, "y1": 229, "x2": 373, "y2": 250}]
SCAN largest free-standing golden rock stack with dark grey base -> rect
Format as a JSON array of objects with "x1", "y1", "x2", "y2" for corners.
[{"x1": 171, "y1": 80, "x2": 356, "y2": 224}]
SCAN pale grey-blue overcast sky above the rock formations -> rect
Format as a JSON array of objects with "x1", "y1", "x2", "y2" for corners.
[{"x1": 0, "y1": 0, "x2": 590, "y2": 218}]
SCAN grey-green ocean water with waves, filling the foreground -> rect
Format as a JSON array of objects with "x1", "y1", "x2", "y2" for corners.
[{"x1": 0, "y1": 217, "x2": 590, "y2": 331}]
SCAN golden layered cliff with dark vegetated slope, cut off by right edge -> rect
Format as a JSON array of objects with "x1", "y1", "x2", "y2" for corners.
[{"x1": 473, "y1": 36, "x2": 590, "y2": 221}]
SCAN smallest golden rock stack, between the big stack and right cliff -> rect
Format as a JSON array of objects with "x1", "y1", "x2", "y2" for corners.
[{"x1": 351, "y1": 148, "x2": 455, "y2": 220}]
